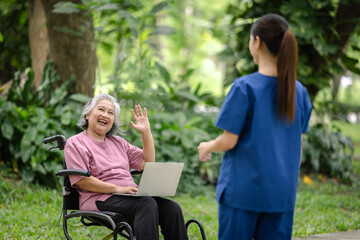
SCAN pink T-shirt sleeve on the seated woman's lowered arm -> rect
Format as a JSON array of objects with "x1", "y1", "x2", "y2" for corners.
[{"x1": 64, "y1": 142, "x2": 91, "y2": 186}]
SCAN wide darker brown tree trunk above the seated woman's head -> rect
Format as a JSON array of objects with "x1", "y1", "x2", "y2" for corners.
[{"x1": 41, "y1": 0, "x2": 97, "y2": 97}]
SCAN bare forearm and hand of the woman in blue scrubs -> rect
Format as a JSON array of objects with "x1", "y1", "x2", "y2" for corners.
[{"x1": 198, "y1": 131, "x2": 239, "y2": 162}]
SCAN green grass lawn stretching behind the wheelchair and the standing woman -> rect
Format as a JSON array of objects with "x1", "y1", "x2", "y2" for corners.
[{"x1": 0, "y1": 167, "x2": 360, "y2": 240}]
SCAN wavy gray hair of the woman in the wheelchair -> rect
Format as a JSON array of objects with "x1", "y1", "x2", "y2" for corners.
[{"x1": 77, "y1": 93, "x2": 123, "y2": 137}]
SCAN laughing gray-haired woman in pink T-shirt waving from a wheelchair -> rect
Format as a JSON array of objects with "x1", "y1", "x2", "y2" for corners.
[{"x1": 64, "y1": 94, "x2": 187, "y2": 240}]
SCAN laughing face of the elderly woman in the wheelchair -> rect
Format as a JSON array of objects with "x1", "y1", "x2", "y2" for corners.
[{"x1": 85, "y1": 99, "x2": 115, "y2": 141}]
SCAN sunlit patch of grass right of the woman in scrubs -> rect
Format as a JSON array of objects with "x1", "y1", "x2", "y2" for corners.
[{"x1": 293, "y1": 180, "x2": 360, "y2": 236}]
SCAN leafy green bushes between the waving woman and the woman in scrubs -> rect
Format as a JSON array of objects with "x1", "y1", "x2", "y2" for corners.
[{"x1": 117, "y1": 64, "x2": 225, "y2": 194}]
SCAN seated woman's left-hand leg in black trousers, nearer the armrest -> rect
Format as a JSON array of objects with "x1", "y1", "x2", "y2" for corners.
[{"x1": 96, "y1": 196, "x2": 159, "y2": 240}]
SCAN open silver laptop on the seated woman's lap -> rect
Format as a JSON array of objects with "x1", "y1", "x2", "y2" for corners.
[{"x1": 113, "y1": 162, "x2": 184, "y2": 197}]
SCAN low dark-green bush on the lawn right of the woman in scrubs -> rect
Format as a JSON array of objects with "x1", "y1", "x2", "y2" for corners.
[{"x1": 301, "y1": 121, "x2": 354, "y2": 183}]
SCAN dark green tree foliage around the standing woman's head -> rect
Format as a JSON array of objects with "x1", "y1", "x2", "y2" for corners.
[{"x1": 222, "y1": 0, "x2": 360, "y2": 97}]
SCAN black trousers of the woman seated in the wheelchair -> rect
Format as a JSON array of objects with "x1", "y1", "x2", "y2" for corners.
[{"x1": 96, "y1": 195, "x2": 188, "y2": 240}]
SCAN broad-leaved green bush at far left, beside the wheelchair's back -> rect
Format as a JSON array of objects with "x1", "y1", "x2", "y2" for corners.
[{"x1": 0, "y1": 62, "x2": 87, "y2": 186}]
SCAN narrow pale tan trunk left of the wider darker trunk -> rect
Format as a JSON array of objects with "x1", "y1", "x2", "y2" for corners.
[{"x1": 28, "y1": 0, "x2": 50, "y2": 87}]
